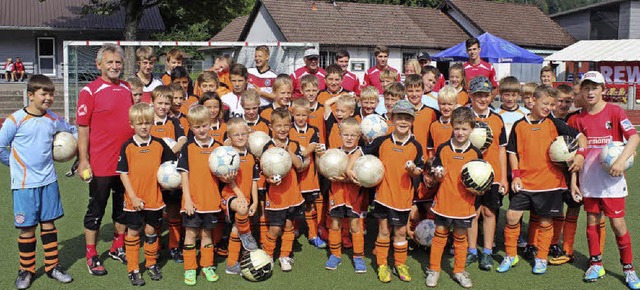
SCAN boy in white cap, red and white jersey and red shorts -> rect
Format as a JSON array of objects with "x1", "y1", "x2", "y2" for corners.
[{"x1": 574, "y1": 71, "x2": 640, "y2": 289}]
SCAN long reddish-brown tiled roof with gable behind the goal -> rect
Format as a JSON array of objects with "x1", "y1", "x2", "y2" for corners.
[{"x1": 228, "y1": 0, "x2": 468, "y2": 49}]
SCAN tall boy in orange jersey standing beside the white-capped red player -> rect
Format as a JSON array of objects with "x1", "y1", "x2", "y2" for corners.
[{"x1": 496, "y1": 83, "x2": 587, "y2": 274}]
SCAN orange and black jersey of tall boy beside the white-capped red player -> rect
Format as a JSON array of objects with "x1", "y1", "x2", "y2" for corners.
[{"x1": 507, "y1": 116, "x2": 580, "y2": 192}]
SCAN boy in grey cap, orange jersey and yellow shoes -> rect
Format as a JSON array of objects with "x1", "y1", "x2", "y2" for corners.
[{"x1": 362, "y1": 100, "x2": 424, "y2": 283}]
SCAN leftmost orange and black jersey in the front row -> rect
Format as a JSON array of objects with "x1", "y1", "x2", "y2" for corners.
[{"x1": 116, "y1": 137, "x2": 176, "y2": 211}]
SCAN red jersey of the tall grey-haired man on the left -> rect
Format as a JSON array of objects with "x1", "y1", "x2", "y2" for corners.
[{"x1": 76, "y1": 78, "x2": 133, "y2": 176}]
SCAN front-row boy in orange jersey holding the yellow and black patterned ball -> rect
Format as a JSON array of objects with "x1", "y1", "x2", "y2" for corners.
[{"x1": 426, "y1": 107, "x2": 482, "y2": 288}]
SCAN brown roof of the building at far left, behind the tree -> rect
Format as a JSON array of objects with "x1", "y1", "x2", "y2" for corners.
[{"x1": 0, "y1": 0, "x2": 165, "y2": 31}]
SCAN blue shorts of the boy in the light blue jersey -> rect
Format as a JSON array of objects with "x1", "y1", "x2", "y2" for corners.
[{"x1": 12, "y1": 181, "x2": 64, "y2": 228}]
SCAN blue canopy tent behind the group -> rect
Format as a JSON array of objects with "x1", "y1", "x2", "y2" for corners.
[{"x1": 431, "y1": 32, "x2": 544, "y2": 64}]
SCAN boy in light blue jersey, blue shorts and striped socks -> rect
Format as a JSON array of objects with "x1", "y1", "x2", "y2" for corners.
[{"x1": 0, "y1": 75, "x2": 78, "y2": 289}]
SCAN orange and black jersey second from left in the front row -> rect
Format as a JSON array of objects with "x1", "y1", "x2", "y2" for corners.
[{"x1": 178, "y1": 138, "x2": 222, "y2": 213}]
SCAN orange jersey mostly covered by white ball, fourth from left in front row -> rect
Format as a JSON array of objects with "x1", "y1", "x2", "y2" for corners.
[{"x1": 262, "y1": 140, "x2": 304, "y2": 210}]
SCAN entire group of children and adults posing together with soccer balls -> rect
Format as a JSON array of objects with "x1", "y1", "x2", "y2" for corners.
[{"x1": 0, "y1": 38, "x2": 640, "y2": 289}]
